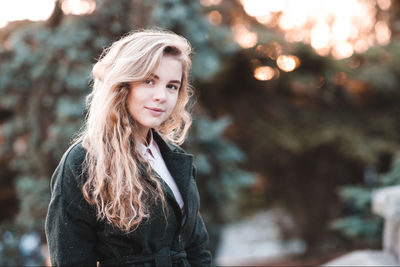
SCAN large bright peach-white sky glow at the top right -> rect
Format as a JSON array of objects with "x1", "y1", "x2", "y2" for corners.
[{"x1": 240, "y1": 0, "x2": 392, "y2": 59}]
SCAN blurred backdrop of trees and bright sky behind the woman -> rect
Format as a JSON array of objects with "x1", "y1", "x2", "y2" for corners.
[{"x1": 0, "y1": 0, "x2": 400, "y2": 266}]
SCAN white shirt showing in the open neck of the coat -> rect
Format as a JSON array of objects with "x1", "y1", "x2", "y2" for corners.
[{"x1": 139, "y1": 131, "x2": 184, "y2": 214}]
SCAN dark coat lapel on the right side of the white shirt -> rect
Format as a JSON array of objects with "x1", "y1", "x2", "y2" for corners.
[{"x1": 152, "y1": 129, "x2": 193, "y2": 208}]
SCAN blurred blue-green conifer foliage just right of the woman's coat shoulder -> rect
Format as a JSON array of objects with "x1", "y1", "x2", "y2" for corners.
[{"x1": 186, "y1": 115, "x2": 254, "y2": 251}]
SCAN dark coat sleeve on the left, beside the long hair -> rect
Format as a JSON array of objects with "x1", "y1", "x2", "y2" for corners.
[{"x1": 45, "y1": 146, "x2": 97, "y2": 266}]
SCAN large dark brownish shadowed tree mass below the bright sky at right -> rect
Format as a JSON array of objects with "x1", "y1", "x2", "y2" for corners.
[{"x1": 196, "y1": 33, "x2": 400, "y2": 250}]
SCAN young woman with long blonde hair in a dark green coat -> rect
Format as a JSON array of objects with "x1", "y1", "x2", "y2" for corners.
[{"x1": 46, "y1": 30, "x2": 211, "y2": 266}]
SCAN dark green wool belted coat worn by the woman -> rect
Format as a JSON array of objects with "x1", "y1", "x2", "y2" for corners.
[{"x1": 46, "y1": 133, "x2": 211, "y2": 266}]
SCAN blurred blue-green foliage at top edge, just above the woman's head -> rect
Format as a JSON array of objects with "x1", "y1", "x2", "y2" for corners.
[{"x1": 149, "y1": 0, "x2": 237, "y2": 79}]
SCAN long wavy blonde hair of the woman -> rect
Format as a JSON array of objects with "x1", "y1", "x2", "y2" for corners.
[{"x1": 79, "y1": 30, "x2": 193, "y2": 232}]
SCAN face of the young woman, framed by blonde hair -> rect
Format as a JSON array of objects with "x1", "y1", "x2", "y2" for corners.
[{"x1": 128, "y1": 56, "x2": 182, "y2": 138}]
